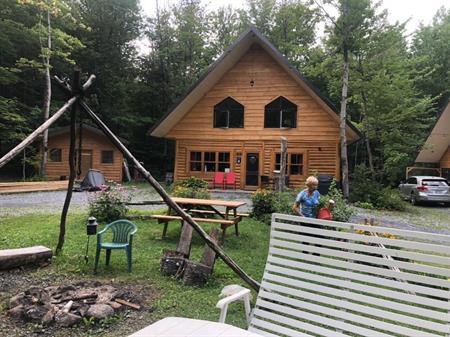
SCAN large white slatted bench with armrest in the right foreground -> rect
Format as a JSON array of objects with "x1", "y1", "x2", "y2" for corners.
[{"x1": 128, "y1": 214, "x2": 450, "y2": 337}]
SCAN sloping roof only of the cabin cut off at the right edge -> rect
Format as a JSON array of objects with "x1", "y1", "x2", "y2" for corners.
[{"x1": 416, "y1": 100, "x2": 450, "y2": 163}]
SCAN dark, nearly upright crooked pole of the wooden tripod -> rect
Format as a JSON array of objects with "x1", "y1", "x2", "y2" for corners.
[{"x1": 56, "y1": 70, "x2": 80, "y2": 254}]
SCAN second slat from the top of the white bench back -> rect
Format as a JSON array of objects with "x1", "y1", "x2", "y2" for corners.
[{"x1": 272, "y1": 223, "x2": 449, "y2": 255}]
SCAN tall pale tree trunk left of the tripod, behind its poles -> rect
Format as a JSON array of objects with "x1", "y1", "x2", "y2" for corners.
[{"x1": 40, "y1": 10, "x2": 52, "y2": 176}]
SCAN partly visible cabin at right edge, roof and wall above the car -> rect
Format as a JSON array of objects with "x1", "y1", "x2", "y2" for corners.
[{"x1": 416, "y1": 101, "x2": 450, "y2": 180}]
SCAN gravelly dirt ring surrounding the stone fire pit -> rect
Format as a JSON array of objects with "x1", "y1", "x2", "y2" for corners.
[{"x1": 0, "y1": 268, "x2": 158, "y2": 337}]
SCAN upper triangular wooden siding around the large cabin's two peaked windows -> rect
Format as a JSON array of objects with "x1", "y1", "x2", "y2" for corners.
[{"x1": 167, "y1": 45, "x2": 339, "y2": 142}]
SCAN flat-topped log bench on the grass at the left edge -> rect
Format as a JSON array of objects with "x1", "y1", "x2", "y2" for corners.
[{"x1": 0, "y1": 246, "x2": 53, "y2": 270}]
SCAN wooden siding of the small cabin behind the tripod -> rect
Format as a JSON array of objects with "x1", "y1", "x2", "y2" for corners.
[{"x1": 47, "y1": 129, "x2": 123, "y2": 182}]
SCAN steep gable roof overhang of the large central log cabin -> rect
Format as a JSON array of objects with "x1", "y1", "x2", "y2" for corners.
[{"x1": 150, "y1": 27, "x2": 360, "y2": 142}]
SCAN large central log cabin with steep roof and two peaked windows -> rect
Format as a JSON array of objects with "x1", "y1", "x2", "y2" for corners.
[{"x1": 151, "y1": 28, "x2": 359, "y2": 190}]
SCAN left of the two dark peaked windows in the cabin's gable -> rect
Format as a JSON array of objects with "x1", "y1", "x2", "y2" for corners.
[{"x1": 214, "y1": 97, "x2": 244, "y2": 128}]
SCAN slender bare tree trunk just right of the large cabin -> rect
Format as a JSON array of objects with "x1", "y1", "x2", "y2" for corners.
[{"x1": 339, "y1": 42, "x2": 349, "y2": 199}]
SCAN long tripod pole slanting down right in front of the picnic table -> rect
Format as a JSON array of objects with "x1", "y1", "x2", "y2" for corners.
[{"x1": 78, "y1": 100, "x2": 260, "y2": 291}]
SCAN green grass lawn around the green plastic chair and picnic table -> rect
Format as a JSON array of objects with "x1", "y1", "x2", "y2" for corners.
[{"x1": 0, "y1": 209, "x2": 270, "y2": 336}]
